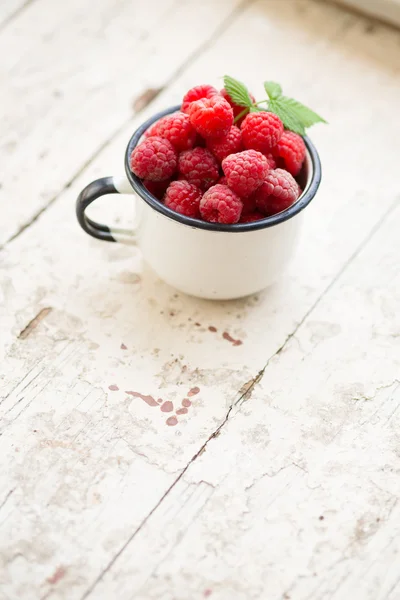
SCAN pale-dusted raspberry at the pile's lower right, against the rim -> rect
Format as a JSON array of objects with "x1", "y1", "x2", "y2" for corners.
[{"x1": 255, "y1": 169, "x2": 299, "y2": 215}]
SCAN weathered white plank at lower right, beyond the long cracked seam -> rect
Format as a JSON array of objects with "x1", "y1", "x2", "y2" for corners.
[{"x1": 101, "y1": 207, "x2": 400, "y2": 600}]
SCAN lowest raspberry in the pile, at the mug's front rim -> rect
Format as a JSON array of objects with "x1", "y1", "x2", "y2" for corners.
[{"x1": 200, "y1": 184, "x2": 243, "y2": 224}]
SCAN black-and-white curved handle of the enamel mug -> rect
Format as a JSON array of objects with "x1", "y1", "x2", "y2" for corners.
[{"x1": 76, "y1": 177, "x2": 136, "y2": 244}]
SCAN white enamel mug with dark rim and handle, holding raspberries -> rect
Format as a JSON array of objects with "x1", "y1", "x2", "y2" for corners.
[{"x1": 76, "y1": 106, "x2": 321, "y2": 300}]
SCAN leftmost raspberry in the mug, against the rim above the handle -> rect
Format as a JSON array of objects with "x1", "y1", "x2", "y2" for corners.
[{"x1": 129, "y1": 137, "x2": 177, "y2": 181}]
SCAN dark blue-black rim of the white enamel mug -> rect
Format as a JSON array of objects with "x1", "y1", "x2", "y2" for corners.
[{"x1": 125, "y1": 105, "x2": 322, "y2": 233}]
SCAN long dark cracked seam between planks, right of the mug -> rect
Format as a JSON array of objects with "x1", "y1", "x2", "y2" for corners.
[{"x1": 81, "y1": 198, "x2": 398, "y2": 600}]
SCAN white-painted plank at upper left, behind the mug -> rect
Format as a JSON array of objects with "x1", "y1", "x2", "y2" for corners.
[{"x1": 0, "y1": 0, "x2": 244, "y2": 244}]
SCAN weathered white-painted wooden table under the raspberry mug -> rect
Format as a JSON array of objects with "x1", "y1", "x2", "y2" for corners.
[{"x1": 0, "y1": 0, "x2": 400, "y2": 600}]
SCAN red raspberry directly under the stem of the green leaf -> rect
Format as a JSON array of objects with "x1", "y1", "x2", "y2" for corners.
[{"x1": 241, "y1": 111, "x2": 283, "y2": 154}]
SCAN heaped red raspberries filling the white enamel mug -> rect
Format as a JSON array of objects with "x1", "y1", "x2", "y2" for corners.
[{"x1": 130, "y1": 85, "x2": 306, "y2": 224}]
